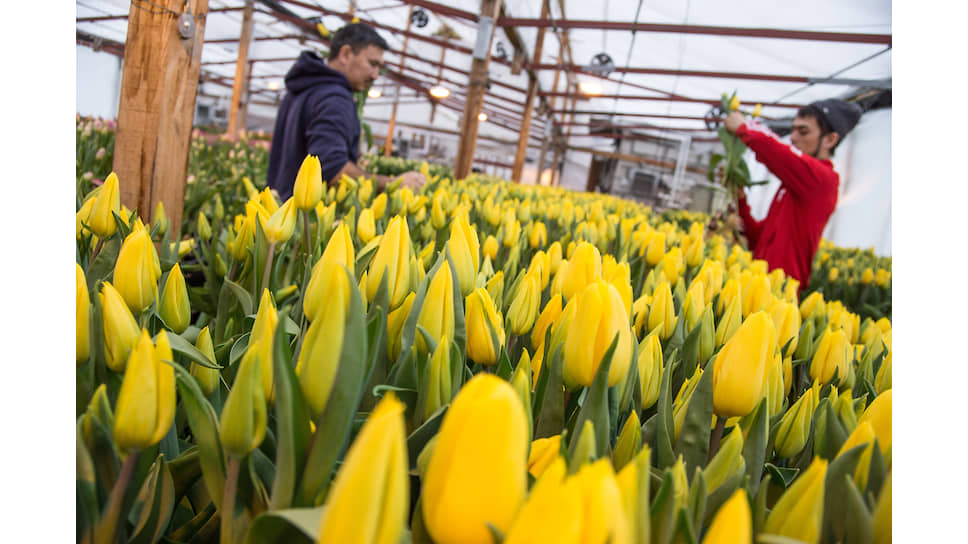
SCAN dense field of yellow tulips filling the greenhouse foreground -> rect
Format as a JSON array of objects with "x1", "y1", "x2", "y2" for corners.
[{"x1": 75, "y1": 138, "x2": 892, "y2": 544}]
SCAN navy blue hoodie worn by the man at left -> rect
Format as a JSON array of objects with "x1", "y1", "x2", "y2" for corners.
[{"x1": 266, "y1": 51, "x2": 360, "y2": 200}]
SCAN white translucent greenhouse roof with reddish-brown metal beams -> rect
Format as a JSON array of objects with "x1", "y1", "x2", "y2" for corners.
[{"x1": 76, "y1": 0, "x2": 892, "y2": 146}]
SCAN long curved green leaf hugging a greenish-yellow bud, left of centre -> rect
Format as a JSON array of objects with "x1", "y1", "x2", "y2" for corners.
[{"x1": 295, "y1": 267, "x2": 368, "y2": 506}]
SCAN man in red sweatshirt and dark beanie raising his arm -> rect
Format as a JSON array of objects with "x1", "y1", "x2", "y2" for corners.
[{"x1": 725, "y1": 99, "x2": 862, "y2": 290}]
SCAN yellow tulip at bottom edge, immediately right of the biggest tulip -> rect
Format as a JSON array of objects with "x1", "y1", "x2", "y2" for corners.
[{"x1": 504, "y1": 456, "x2": 583, "y2": 544}]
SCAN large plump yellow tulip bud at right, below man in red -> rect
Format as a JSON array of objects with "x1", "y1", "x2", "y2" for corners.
[{"x1": 713, "y1": 311, "x2": 776, "y2": 417}]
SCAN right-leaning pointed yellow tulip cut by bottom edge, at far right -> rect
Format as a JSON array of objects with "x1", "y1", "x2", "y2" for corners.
[{"x1": 763, "y1": 457, "x2": 827, "y2": 542}]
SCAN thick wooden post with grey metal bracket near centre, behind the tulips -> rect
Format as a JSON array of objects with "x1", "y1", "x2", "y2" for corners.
[{"x1": 454, "y1": 0, "x2": 501, "y2": 183}]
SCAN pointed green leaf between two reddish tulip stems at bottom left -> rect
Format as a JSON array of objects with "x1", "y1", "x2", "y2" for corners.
[{"x1": 128, "y1": 455, "x2": 175, "y2": 544}]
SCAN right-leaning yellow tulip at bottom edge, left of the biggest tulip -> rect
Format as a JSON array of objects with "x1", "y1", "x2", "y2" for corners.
[{"x1": 316, "y1": 393, "x2": 410, "y2": 544}]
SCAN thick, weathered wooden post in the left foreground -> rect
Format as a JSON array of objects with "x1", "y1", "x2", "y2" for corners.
[{"x1": 114, "y1": 0, "x2": 208, "y2": 239}]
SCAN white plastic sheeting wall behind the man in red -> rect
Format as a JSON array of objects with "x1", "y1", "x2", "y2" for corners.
[{"x1": 746, "y1": 109, "x2": 891, "y2": 256}]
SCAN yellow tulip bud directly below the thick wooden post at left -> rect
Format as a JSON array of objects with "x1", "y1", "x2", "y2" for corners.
[{"x1": 114, "y1": 229, "x2": 161, "y2": 314}]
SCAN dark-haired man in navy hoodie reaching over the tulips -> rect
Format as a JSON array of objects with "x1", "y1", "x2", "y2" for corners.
[{"x1": 266, "y1": 23, "x2": 426, "y2": 200}]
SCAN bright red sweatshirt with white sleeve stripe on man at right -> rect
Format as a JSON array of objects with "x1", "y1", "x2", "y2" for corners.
[{"x1": 736, "y1": 121, "x2": 840, "y2": 289}]
